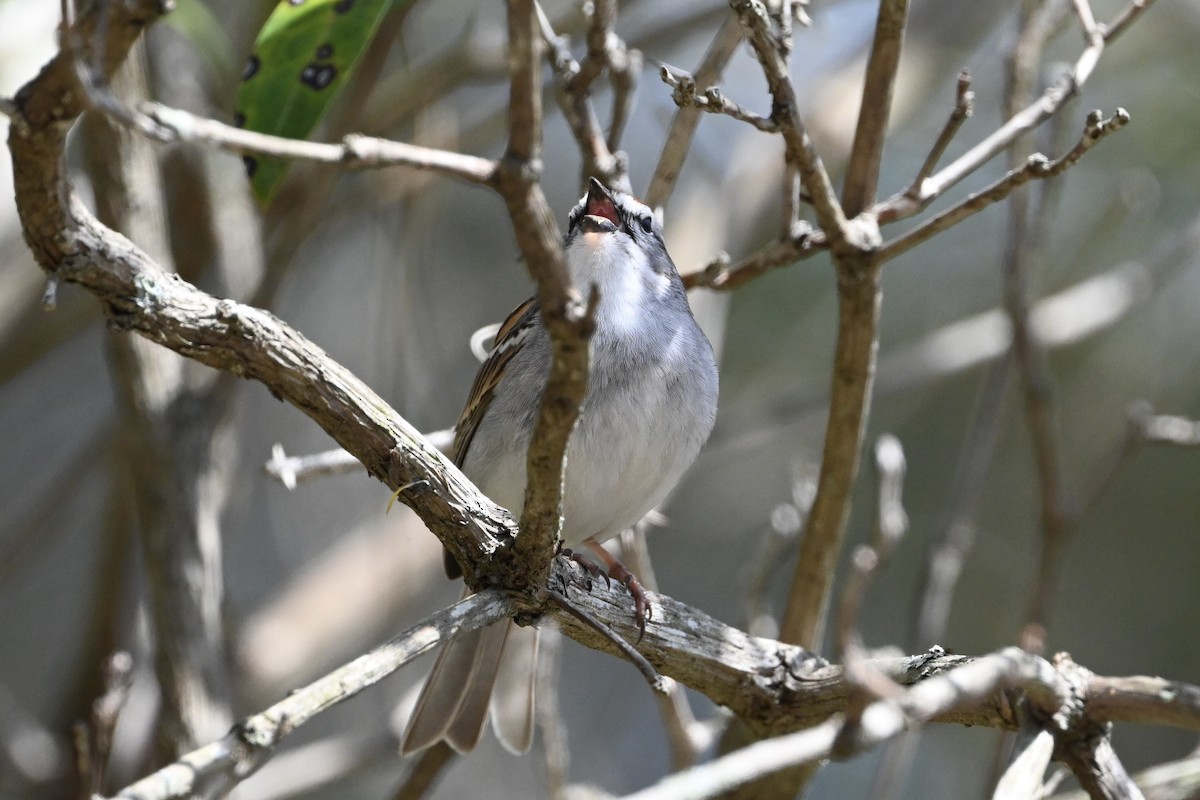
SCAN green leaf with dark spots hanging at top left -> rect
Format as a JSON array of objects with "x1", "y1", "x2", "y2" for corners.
[{"x1": 235, "y1": 0, "x2": 396, "y2": 207}]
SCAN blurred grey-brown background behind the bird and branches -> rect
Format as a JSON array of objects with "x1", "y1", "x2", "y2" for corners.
[{"x1": 0, "y1": 0, "x2": 1200, "y2": 799}]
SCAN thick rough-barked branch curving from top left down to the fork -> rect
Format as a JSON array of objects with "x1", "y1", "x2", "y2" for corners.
[{"x1": 8, "y1": 2, "x2": 512, "y2": 582}]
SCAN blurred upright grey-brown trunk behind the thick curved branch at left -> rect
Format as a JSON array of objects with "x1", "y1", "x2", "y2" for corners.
[{"x1": 80, "y1": 32, "x2": 234, "y2": 754}]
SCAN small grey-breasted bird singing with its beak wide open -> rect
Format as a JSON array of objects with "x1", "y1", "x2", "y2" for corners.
[{"x1": 401, "y1": 178, "x2": 718, "y2": 754}]
